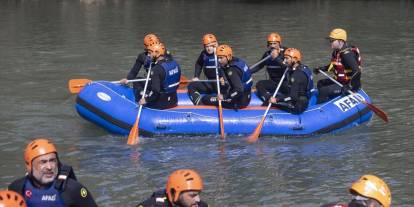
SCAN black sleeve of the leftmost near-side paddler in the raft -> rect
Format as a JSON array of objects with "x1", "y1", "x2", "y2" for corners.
[{"x1": 146, "y1": 65, "x2": 165, "y2": 103}]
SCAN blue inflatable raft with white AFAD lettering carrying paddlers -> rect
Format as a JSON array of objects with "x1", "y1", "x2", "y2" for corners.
[{"x1": 76, "y1": 81, "x2": 373, "y2": 136}]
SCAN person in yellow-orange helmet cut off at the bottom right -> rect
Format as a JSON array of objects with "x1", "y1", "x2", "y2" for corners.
[{"x1": 321, "y1": 175, "x2": 391, "y2": 207}]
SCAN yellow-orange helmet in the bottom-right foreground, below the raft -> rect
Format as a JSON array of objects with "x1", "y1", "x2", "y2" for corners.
[{"x1": 349, "y1": 175, "x2": 391, "y2": 207}]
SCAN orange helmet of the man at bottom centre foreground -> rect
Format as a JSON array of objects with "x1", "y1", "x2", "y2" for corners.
[{"x1": 166, "y1": 169, "x2": 203, "y2": 203}]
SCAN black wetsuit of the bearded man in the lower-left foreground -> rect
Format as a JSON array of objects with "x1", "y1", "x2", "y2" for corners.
[{"x1": 8, "y1": 166, "x2": 97, "y2": 207}]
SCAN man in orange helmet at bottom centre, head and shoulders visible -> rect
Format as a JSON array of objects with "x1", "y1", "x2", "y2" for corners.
[{"x1": 136, "y1": 169, "x2": 208, "y2": 207}]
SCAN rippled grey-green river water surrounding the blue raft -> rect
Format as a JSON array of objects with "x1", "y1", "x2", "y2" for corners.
[{"x1": 0, "y1": 0, "x2": 414, "y2": 206}]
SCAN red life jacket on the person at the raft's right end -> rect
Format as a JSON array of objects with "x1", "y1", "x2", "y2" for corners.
[{"x1": 328, "y1": 46, "x2": 362, "y2": 84}]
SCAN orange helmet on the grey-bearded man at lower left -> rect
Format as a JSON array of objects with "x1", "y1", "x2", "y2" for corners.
[{"x1": 24, "y1": 138, "x2": 57, "y2": 172}]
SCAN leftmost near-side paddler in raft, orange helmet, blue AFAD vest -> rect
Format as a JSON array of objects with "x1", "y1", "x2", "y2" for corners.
[{"x1": 138, "y1": 42, "x2": 181, "y2": 109}]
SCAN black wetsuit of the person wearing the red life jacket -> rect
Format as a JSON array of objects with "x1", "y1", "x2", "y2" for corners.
[{"x1": 317, "y1": 45, "x2": 361, "y2": 103}]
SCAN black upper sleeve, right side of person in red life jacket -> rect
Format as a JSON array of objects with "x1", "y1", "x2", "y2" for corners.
[{"x1": 341, "y1": 49, "x2": 361, "y2": 90}]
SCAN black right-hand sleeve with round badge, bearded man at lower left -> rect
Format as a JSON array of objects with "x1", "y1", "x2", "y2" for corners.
[{"x1": 61, "y1": 179, "x2": 98, "y2": 207}]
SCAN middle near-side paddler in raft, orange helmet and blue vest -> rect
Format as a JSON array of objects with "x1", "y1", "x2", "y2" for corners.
[{"x1": 201, "y1": 45, "x2": 253, "y2": 109}]
